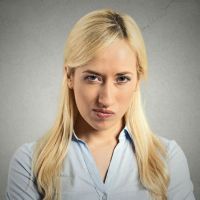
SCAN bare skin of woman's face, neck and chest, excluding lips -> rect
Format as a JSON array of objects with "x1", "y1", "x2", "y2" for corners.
[{"x1": 68, "y1": 40, "x2": 138, "y2": 181}]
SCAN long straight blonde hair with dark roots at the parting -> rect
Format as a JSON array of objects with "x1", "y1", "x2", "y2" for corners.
[{"x1": 33, "y1": 9, "x2": 169, "y2": 200}]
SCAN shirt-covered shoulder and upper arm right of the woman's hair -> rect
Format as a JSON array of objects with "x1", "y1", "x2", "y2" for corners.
[{"x1": 159, "y1": 136, "x2": 195, "y2": 200}]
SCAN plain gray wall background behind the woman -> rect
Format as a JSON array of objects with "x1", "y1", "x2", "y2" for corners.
[{"x1": 0, "y1": 0, "x2": 200, "y2": 199}]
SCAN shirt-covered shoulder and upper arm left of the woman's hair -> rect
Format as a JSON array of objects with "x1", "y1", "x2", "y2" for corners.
[{"x1": 5, "y1": 142, "x2": 41, "y2": 200}]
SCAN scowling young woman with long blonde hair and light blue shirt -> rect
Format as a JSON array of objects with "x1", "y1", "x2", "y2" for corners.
[{"x1": 6, "y1": 9, "x2": 195, "y2": 200}]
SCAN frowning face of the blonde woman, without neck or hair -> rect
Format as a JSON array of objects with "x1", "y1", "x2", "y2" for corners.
[{"x1": 70, "y1": 40, "x2": 137, "y2": 131}]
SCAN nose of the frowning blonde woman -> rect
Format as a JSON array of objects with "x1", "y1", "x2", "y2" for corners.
[{"x1": 98, "y1": 81, "x2": 115, "y2": 108}]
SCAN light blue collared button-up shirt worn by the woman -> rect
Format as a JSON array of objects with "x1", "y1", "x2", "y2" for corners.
[{"x1": 6, "y1": 127, "x2": 195, "y2": 200}]
